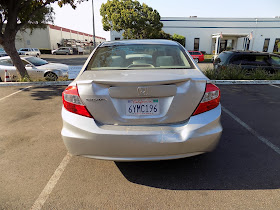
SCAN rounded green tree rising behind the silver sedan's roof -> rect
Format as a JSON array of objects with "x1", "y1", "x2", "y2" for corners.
[{"x1": 100, "y1": 0, "x2": 163, "y2": 39}]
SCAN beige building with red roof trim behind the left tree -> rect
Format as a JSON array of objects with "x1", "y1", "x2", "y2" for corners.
[{"x1": 13, "y1": 24, "x2": 106, "y2": 50}]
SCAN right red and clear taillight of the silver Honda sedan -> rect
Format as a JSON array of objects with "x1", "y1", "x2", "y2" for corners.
[{"x1": 192, "y1": 83, "x2": 221, "y2": 116}]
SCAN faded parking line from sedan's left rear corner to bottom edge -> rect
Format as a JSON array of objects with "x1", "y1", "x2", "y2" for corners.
[{"x1": 31, "y1": 152, "x2": 72, "y2": 210}]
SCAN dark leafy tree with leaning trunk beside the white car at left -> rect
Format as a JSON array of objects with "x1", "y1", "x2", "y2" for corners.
[{"x1": 0, "y1": 0, "x2": 84, "y2": 78}]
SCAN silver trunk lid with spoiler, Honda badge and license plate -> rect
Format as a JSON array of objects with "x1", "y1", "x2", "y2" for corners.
[{"x1": 76, "y1": 69, "x2": 208, "y2": 125}]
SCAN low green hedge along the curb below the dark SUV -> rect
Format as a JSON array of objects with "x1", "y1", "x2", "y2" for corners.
[{"x1": 204, "y1": 65, "x2": 280, "y2": 80}]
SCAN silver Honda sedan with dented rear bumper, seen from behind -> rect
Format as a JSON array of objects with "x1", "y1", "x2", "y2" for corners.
[{"x1": 61, "y1": 40, "x2": 222, "y2": 161}]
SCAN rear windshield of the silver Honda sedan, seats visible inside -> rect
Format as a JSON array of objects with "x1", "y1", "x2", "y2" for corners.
[{"x1": 87, "y1": 44, "x2": 191, "y2": 70}]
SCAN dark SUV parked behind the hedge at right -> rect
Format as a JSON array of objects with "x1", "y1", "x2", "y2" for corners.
[{"x1": 213, "y1": 51, "x2": 280, "y2": 73}]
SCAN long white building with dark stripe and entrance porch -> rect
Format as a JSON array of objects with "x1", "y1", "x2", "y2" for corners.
[{"x1": 111, "y1": 17, "x2": 280, "y2": 54}]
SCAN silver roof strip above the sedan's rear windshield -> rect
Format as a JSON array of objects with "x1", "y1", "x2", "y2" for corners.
[{"x1": 100, "y1": 39, "x2": 178, "y2": 47}]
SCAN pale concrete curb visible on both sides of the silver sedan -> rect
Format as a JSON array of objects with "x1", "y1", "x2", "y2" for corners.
[{"x1": 0, "y1": 80, "x2": 280, "y2": 87}]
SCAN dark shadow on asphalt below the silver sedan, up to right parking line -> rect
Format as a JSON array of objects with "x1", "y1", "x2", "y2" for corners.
[{"x1": 115, "y1": 114, "x2": 280, "y2": 190}]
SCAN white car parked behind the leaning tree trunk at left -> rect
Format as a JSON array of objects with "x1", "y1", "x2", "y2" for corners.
[{"x1": 0, "y1": 56, "x2": 69, "y2": 81}]
